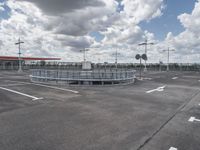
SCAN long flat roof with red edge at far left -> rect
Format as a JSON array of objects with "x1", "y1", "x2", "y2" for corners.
[{"x1": 0, "y1": 56, "x2": 61, "y2": 61}]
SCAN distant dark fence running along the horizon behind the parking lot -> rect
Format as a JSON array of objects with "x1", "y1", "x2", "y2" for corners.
[{"x1": 0, "y1": 64, "x2": 200, "y2": 71}]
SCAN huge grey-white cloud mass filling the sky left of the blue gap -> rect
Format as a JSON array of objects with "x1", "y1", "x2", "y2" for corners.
[{"x1": 0, "y1": 0, "x2": 166, "y2": 61}]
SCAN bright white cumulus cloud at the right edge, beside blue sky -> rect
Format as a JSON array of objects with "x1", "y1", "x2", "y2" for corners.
[{"x1": 158, "y1": 1, "x2": 200, "y2": 62}]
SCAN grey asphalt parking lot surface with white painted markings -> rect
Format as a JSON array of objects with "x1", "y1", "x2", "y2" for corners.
[{"x1": 0, "y1": 71, "x2": 200, "y2": 150}]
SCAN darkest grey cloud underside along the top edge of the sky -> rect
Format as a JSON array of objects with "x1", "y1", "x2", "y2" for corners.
[{"x1": 17, "y1": 0, "x2": 105, "y2": 15}]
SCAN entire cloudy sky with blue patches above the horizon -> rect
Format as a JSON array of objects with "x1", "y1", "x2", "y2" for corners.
[{"x1": 0, "y1": 0, "x2": 200, "y2": 63}]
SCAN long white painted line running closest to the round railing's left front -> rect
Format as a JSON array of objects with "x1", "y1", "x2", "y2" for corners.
[{"x1": 7, "y1": 80, "x2": 79, "y2": 94}]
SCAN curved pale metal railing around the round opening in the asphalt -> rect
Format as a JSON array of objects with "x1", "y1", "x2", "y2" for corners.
[{"x1": 30, "y1": 69, "x2": 135, "y2": 81}]
